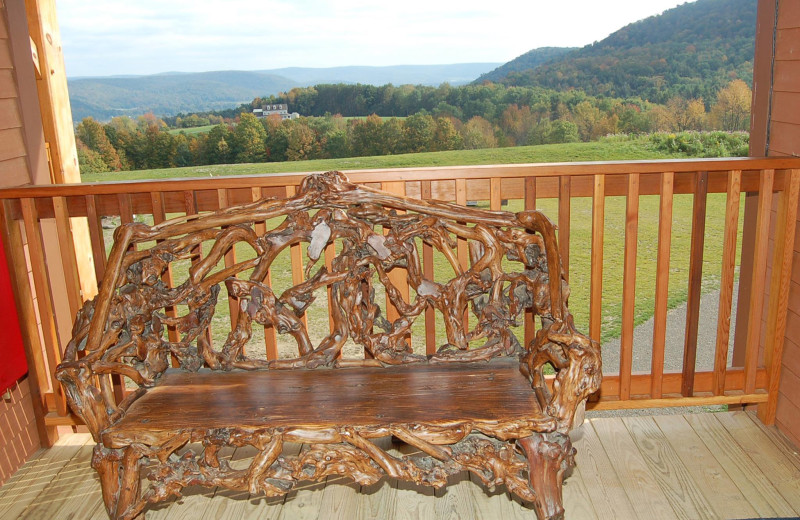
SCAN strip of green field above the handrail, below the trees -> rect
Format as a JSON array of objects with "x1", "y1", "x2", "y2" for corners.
[{"x1": 81, "y1": 136, "x2": 687, "y2": 182}]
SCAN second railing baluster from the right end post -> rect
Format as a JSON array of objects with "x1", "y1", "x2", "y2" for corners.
[{"x1": 713, "y1": 170, "x2": 742, "y2": 395}]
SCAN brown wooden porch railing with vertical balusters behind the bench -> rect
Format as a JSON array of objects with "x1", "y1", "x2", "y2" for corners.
[{"x1": 0, "y1": 157, "x2": 800, "y2": 438}]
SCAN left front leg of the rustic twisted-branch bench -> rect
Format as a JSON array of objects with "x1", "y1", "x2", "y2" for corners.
[{"x1": 92, "y1": 444, "x2": 144, "y2": 520}]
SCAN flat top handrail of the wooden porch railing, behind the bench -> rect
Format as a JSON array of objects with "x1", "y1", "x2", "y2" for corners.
[{"x1": 0, "y1": 157, "x2": 800, "y2": 199}]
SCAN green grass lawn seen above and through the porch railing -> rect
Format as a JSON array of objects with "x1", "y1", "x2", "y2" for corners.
[{"x1": 95, "y1": 135, "x2": 743, "y2": 355}]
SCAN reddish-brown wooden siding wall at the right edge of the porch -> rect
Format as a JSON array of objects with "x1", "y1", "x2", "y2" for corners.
[{"x1": 751, "y1": 0, "x2": 800, "y2": 445}]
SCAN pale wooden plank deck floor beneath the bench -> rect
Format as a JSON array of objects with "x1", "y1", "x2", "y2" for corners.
[{"x1": 0, "y1": 412, "x2": 800, "y2": 520}]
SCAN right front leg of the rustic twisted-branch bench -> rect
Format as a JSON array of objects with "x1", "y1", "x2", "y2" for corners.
[{"x1": 517, "y1": 433, "x2": 575, "y2": 520}]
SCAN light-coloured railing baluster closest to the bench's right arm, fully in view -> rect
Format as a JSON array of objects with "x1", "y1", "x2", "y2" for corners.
[{"x1": 589, "y1": 175, "x2": 606, "y2": 343}]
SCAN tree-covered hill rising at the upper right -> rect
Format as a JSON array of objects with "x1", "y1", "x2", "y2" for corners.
[{"x1": 482, "y1": 0, "x2": 757, "y2": 103}]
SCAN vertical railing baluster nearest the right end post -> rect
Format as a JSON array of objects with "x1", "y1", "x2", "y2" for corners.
[{"x1": 744, "y1": 169, "x2": 775, "y2": 394}]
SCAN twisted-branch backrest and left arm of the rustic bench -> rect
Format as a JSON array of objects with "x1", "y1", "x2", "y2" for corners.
[{"x1": 58, "y1": 172, "x2": 599, "y2": 432}]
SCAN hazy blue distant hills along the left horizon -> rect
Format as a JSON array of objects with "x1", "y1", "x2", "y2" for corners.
[{"x1": 69, "y1": 63, "x2": 498, "y2": 122}]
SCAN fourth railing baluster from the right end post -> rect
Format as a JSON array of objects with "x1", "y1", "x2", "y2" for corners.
[{"x1": 650, "y1": 172, "x2": 675, "y2": 399}]
